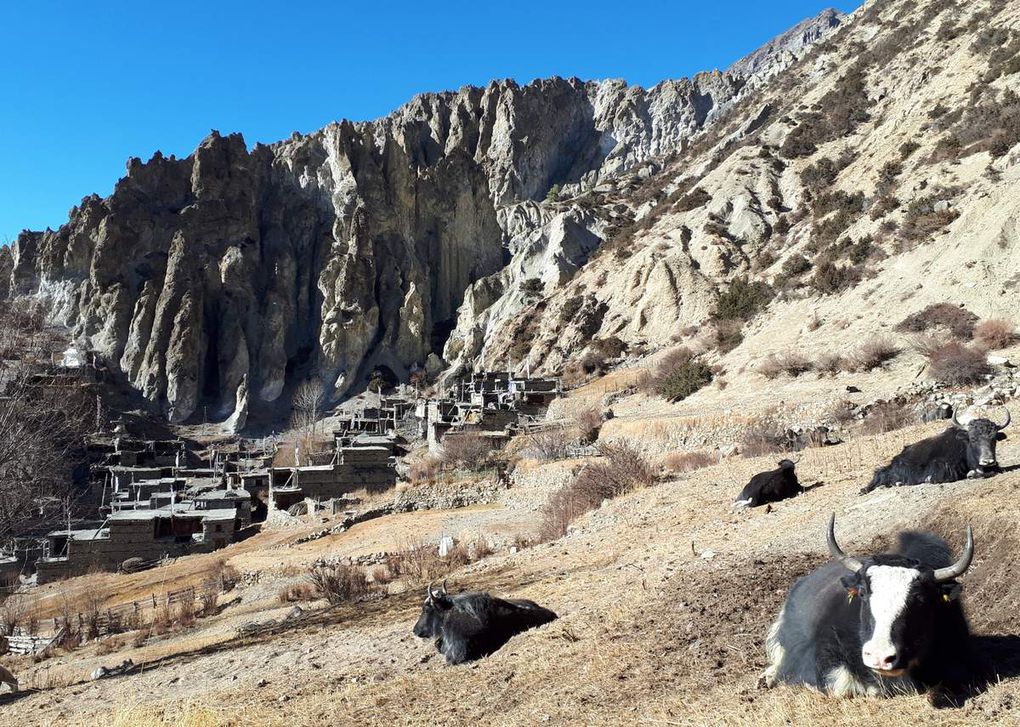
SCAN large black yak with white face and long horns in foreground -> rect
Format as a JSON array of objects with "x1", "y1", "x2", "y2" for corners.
[{"x1": 764, "y1": 515, "x2": 974, "y2": 696}]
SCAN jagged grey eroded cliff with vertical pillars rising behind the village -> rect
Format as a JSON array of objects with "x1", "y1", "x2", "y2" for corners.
[{"x1": 10, "y1": 8, "x2": 838, "y2": 426}]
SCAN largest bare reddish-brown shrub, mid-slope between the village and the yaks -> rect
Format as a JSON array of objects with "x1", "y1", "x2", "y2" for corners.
[{"x1": 539, "y1": 444, "x2": 656, "y2": 540}]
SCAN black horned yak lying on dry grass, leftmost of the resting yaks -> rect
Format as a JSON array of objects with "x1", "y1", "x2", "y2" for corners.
[{"x1": 414, "y1": 583, "x2": 557, "y2": 664}]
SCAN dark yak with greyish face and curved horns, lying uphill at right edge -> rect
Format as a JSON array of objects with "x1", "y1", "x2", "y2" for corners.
[{"x1": 861, "y1": 410, "x2": 1010, "y2": 495}]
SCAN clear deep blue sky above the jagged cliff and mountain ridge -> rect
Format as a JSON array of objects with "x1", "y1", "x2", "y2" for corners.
[{"x1": 0, "y1": 0, "x2": 859, "y2": 242}]
